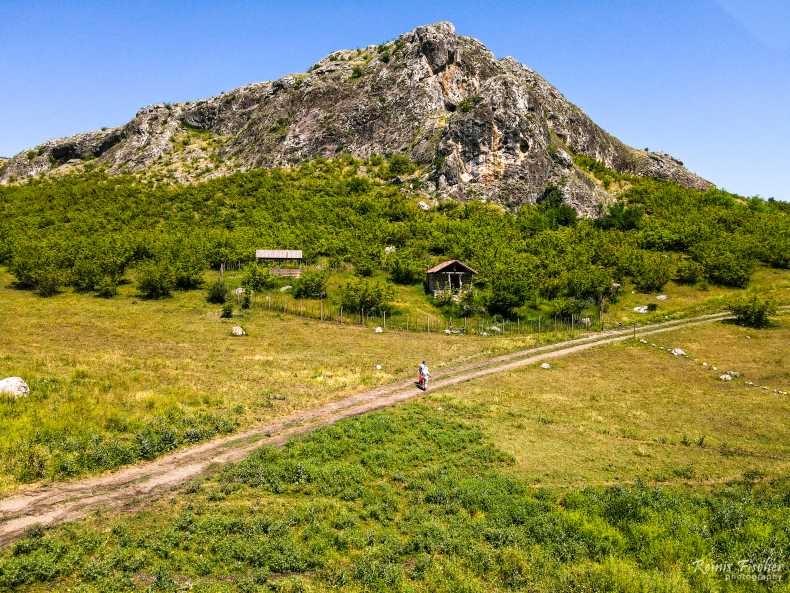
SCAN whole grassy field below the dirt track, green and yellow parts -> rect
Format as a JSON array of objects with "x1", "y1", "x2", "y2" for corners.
[{"x1": 0, "y1": 315, "x2": 790, "y2": 593}]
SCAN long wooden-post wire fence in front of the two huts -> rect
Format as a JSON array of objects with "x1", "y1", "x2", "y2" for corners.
[{"x1": 244, "y1": 295, "x2": 607, "y2": 336}]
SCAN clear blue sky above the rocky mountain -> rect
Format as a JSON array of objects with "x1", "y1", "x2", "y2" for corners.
[{"x1": 0, "y1": 0, "x2": 790, "y2": 199}]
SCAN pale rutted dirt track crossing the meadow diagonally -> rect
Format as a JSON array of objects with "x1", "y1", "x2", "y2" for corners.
[{"x1": 0, "y1": 314, "x2": 728, "y2": 547}]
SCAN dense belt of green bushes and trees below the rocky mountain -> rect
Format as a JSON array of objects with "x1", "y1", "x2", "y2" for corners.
[{"x1": 0, "y1": 157, "x2": 790, "y2": 315}]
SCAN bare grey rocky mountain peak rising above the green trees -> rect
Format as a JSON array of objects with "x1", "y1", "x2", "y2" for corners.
[{"x1": 0, "y1": 23, "x2": 710, "y2": 212}]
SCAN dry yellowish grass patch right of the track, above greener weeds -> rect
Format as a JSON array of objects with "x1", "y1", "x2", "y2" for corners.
[{"x1": 433, "y1": 316, "x2": 790, "y2": 485}]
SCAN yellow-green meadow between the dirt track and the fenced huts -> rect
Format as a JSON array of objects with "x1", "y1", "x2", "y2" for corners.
[{"x1": 0, "y1": 272, "x2": 544, "y2": 492}]
